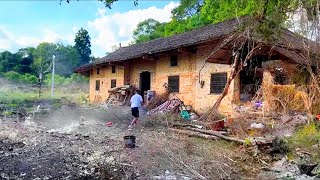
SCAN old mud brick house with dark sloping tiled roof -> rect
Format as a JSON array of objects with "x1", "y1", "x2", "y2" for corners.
[{"x1": 75, "y1": 19, "x2": 318, "y2": 113}]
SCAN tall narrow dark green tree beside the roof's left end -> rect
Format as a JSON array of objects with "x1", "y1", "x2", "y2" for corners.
[{"x1": 74, "y1": 28, "x2": 91, "y2": 65}]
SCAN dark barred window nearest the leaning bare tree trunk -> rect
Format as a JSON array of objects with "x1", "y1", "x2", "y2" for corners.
[{"x1": 210, "y1": 73, "x2": 227, "y2": 94}]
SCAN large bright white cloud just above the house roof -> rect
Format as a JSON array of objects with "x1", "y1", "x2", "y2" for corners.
[{"x1": 88, "y1": 2, "x2": 178, "y2": 56}]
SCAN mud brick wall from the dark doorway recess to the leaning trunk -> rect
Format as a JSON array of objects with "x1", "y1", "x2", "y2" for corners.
[{"x1": 130, "y1": 47, "x2": 238, "y2": 114}]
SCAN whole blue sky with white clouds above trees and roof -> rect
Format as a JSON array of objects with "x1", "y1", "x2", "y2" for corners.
[{"x1": 0, "y1": 0, "x2": 178, "y2": 57}]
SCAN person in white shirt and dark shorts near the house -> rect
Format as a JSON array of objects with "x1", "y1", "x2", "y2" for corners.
[{"x1": 129, "y1": 90, "x2": 143, "y2": 129}]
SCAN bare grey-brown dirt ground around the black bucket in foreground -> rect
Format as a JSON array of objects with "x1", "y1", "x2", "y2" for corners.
[{"x1": 0, "y1": 106, "x2": 260, "y2": 179}]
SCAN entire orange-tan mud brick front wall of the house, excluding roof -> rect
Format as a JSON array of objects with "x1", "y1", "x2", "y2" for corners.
[{"x1": 90, "y1": 44, "x2": 239, "y2": 114}]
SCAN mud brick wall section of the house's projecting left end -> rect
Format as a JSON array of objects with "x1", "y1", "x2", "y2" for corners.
[{"x1": 89, "y1": 66, "x2": 124, "y2": 103}]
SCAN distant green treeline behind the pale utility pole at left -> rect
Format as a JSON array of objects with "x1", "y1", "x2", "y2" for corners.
[{"x1": 0, "y1": 43, "x2": 87, "y2": 84}]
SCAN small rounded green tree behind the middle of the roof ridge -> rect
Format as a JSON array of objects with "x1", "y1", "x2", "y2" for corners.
[{"x1": 133, "y1": 18, "x2": 164, "y2": 43}]
